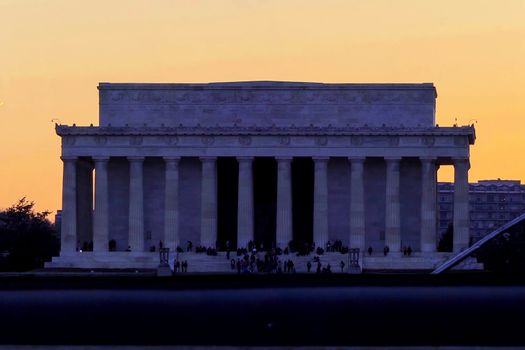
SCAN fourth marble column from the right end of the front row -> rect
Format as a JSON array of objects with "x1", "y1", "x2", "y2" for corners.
[{"x1": 349, "y1": 157, "x2": 365, "y2": 256}]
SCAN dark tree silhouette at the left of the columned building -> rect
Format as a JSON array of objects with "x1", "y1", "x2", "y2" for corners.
[{"x1": 0, "y1": 197, "x2": 60, "y2": 271}]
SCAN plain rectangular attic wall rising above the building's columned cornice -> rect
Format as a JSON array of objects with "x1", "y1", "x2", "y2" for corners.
[{"x1": 98, "y1": 82, "x2": 436, "y2": 127}]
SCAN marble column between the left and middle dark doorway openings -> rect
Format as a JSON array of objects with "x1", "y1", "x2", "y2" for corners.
[{"x1": 237, "y1": 157, "x2": 254, "y2": 247}]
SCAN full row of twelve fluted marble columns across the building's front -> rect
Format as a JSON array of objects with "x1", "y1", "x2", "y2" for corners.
[{"x1": 61, "y1": 157, "x2": 469, "y2": 255}]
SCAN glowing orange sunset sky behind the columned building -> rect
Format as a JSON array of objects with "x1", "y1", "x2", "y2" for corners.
[{"x1": 0, "y1": 0, "x2": 525, "y2": 211}]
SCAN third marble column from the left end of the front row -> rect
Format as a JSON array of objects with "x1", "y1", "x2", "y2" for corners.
[{"x1": 128, "y1": 157, "x2": 144, "y2": 253}]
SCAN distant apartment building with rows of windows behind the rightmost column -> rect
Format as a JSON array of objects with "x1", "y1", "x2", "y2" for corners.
[{"x1": 438, "y1": 179, "x2": 525, "y2": 242}]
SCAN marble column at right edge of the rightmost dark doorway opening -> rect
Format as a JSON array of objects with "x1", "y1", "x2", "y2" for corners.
[{"x1": 313, "y1": 157, "x2": 329, "y2": 249}]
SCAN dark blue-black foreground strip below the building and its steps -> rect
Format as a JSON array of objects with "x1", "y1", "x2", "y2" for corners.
[{"x1": 0, "y1": 273, "x2": 525, "y2": 346}]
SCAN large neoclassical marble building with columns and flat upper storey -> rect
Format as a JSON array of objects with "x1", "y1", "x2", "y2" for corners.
[{"x1": 48, "y1": 81, "x2": 475, "y2": 268}]
